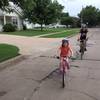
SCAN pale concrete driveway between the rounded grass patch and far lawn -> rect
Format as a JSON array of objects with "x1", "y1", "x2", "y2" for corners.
[{"x1": 0, "y1": 34, "x2": 61, "y2": 55}]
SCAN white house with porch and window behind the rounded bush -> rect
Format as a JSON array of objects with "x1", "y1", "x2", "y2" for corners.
[{"x1": 0, "y1": 2, "x2": 22, "y2": 31}]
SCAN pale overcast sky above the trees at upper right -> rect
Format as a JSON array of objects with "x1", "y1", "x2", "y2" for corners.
[{"x1": 58, "y1": 0, "x2": 100, "y2": 16}]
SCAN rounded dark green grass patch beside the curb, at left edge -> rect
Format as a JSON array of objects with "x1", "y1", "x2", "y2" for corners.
[{"x1": 0, "y1": 44, "x2": 19, "y2": 62}]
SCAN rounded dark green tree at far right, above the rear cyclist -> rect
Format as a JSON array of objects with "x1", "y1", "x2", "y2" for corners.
[{"x1": 78, "y1": 6, "x2": 98, "y2": 27}]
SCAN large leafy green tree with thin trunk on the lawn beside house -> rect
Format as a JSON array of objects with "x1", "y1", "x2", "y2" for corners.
[{"x1": 24, "y1": 0, "x2": 63, "y2": 30}]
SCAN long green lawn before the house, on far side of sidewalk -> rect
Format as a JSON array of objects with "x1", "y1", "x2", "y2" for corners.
[{"x1": 2, "y1": 28, "x2": 68, "y2": 36}]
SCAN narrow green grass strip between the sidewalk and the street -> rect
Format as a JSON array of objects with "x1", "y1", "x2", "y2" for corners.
[{"x1": 43, "y1": 29, "x2": 79, "y2": 38}]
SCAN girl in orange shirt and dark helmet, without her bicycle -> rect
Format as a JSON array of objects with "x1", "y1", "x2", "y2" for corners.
[{"x1": 59, "y1": 39, "x2": 73, "y2": 71}]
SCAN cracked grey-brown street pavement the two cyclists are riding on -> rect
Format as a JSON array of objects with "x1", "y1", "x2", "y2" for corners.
[{"x1": 0, "y1": 29, "x2": 100, "y2": 100}]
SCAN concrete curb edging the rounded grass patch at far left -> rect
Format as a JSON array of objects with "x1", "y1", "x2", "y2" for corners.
[{"x1": 0, "y1": 55, "x2": 27, "y2": 71}]
